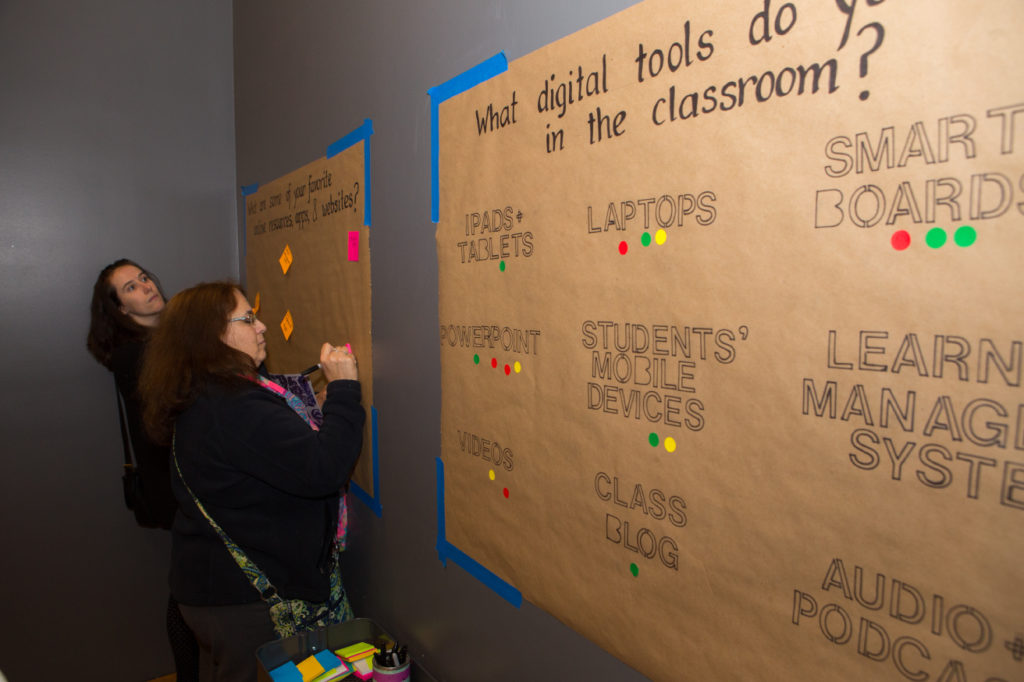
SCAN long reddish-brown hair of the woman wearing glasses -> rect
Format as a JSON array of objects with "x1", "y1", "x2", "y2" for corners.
[{"x1": 139, "y1": 282, "x2": 256, "y2": 442}]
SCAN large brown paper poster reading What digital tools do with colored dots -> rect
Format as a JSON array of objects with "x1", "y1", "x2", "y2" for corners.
[{"x1": 437, "y1": 0, "x2": 1024, "y2": 682}]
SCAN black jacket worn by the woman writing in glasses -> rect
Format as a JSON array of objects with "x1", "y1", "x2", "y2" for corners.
[{"x1": 165, "y1": 381, "x2": 366, "y2": 606}]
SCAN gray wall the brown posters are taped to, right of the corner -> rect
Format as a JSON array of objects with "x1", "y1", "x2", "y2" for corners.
[{"x1": 234, "y1": 0, "x2": 644, "y2": 682}]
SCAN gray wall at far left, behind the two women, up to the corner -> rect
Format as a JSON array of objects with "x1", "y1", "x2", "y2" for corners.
[{"x1": 0, "y1": 0, "x2": 238, "y2": 682}]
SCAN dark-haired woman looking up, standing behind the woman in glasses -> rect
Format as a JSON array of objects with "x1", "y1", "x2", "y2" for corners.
[{"x1": 86, "y1": 258, "x2": 199, "y2": 682}]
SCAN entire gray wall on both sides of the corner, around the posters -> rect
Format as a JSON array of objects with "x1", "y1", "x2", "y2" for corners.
[{"x1": 0, "y1": 0, "x2": 643, "y2": 682}]
